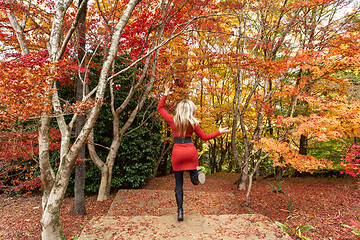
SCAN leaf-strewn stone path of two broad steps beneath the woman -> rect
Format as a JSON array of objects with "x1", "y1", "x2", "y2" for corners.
[{"x1": 80, "y1": 189, "x2": 291, "y2": 240}]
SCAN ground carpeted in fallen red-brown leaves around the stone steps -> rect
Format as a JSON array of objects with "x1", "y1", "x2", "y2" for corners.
[{"x1": 0, "y1": 172, "x2": 360, "y2": 240}]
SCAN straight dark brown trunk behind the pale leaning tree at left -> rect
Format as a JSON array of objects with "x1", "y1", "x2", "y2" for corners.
[{"x1": 72, "y1": 0, "x2": 87, "y2": 215}]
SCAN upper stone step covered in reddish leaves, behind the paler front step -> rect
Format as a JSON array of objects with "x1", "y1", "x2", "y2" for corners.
[{"x1": 108, "y1": 189, "x2": 244, "y2": 216}]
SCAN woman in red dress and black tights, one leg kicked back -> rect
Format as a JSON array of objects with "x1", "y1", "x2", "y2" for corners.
[{"x1": 157, "y1": 84, "x2": 230, "y2": 221}]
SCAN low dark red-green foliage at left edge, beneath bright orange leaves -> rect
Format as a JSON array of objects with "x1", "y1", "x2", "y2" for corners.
[{"x1": 0, "y1": 123, "x2": 60, "y2": 194}]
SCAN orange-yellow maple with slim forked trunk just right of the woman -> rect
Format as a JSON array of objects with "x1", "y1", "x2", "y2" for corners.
[{"x1": 162, "y1": 1, "x2": 357, "y2": 206}]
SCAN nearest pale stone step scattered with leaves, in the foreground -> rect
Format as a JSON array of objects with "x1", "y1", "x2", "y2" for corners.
[{"x1": 79, "y1": 214, "x2": 291, "y2": 240}]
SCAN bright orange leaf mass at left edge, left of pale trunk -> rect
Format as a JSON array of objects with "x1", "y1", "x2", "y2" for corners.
[{"x1": 0, "y1": 53, "x2": 51, "y2": 129}]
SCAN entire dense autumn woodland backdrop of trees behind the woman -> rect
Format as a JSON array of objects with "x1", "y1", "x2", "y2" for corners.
[{"x1": 0, "y1": 0, "x2": 360, "y2": 239}]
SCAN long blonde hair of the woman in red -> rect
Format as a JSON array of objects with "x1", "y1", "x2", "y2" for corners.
[{"x1": 174, "y1": 100, "x2": 199, "y2": 137}]
